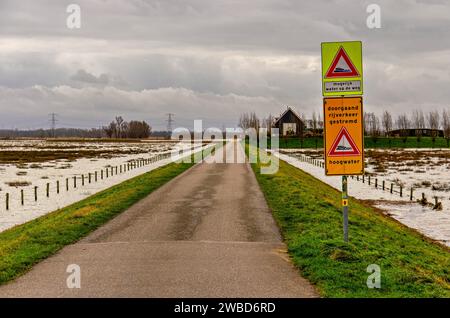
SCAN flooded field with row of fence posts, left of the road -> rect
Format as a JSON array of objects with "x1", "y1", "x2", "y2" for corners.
[{"x1": 0, "y1": 140, "x2": 207, "y2": 231}]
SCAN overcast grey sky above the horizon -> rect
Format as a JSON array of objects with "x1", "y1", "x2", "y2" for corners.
[{"x1": 0, "y1": 0, "x2": 450, "y2": 130}]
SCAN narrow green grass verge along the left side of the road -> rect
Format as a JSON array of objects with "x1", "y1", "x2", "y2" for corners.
[{"x1": 0, "y1": 163, "x2": 194, "y2": 284}]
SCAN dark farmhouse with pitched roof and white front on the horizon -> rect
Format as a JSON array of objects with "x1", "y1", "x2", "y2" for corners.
[{"x1": 272, "y1": 106, "x2": 323, "y2": 137}]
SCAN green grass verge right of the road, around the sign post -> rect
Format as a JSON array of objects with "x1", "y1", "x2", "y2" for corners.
[{"x1": 252, "y1": 150, "x2": 450, "y2": 297}]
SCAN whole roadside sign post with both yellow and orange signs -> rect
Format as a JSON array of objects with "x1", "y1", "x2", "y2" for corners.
[{"x1": 321, "y1": 41, "x2": 364, "y2": 242}]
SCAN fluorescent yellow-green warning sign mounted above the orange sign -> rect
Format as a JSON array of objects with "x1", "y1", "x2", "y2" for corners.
[{"x1": 322, "y1": 41, "x2": 363, "y2": 96}]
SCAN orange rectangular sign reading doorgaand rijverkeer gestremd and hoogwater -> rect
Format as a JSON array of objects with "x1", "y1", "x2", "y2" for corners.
[{"x1": 323, "y1": 97, "x2": 364, "y2": 176}]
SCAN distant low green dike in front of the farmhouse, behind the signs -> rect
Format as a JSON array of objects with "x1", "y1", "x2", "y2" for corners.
[{"x1": 280, "y1": 137, "x2": 449, "y2": 149}]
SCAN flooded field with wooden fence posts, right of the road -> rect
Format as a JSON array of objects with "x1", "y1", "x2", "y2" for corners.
[{"x1": 279, "y1": 149, "x2": 450, "y2": 246}]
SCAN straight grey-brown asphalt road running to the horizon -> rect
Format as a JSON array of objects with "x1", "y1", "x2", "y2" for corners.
[{"x1": 0, "y1": 143, "x2": 317, "y2": 297}]
